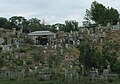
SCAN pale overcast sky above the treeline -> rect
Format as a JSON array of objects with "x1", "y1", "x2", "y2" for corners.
[{"x1": 0, "y1": 0, "x2": 120, "y2": 24}]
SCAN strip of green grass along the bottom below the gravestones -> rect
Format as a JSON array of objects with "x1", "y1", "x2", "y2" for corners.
[{"x1": 0, "y1": 77, "x2": 120, "y2": 84}]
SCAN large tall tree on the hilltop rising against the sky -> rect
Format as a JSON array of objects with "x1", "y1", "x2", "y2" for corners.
[{"x1": 84, "y1": 1, "x2": 119, "y2": 25}]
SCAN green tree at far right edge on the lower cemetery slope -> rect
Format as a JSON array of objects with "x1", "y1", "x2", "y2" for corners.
[{"x1": 102, "y1": 41, "x2": 119, "y2": 69}]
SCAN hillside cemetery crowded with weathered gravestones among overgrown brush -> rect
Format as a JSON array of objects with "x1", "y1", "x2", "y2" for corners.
[{"x1": 0, "y1": 20, "x2": 120, "y2": 82}]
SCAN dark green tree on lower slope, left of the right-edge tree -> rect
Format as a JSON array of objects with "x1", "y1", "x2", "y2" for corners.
[{"x1": 79, "y1": 42, "x2": 101, "y2": 69}]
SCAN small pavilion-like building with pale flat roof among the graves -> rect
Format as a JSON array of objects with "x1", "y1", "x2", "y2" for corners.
[{"x1": 28, "y1": 31, "x2": 56, "y2": 45}]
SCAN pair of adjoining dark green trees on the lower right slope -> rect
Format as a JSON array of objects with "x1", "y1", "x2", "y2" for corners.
[{"x1": 79, "y1": 41, "x2": 119, "y2": 73}]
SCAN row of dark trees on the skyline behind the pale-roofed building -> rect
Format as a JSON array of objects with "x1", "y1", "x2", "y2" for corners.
[{"x1": 0, "y1": 16, "x2": 78, "y2": 33}]
